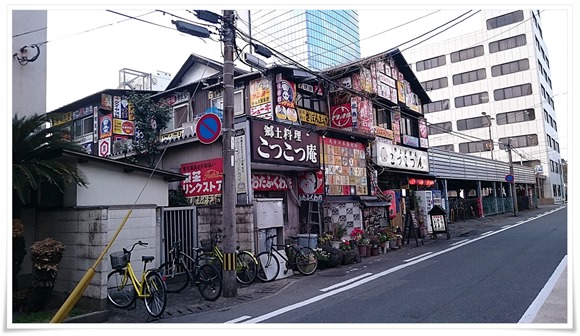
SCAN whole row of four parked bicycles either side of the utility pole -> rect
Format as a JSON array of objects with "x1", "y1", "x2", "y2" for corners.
[{"x1": 107, "y1": 235, "x2": 318, "y2": 317}]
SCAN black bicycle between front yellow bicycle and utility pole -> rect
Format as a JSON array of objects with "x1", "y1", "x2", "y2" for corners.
[{"x1": 159, "y1": 241, "x2": 223, "y2": 301}]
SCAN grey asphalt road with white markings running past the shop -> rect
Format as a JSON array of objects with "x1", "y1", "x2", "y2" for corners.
[{"x1": 158, "y1": 206, "x2": 568, "y2": 327}]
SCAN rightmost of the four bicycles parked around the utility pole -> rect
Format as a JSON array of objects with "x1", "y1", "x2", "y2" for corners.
[{"x1": 256, "y1": 235, "x2": 318, "y2": 282}]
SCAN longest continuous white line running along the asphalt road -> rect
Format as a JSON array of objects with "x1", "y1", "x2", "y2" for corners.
[{"x1": 241, "y1": 207, "x2": 568, "y2": 323}]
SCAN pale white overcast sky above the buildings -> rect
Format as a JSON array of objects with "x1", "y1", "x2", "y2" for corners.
[{"x1": 30, "y1": 4, "x2": 572, "y2": 163}]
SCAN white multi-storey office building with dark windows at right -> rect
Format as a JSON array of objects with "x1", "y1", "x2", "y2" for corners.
[{"x1": 404, "y1": 10, "x2": 566, "y2": 203}]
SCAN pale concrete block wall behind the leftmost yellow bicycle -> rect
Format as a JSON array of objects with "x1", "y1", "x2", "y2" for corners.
[{"x1": 35, "y1": 205, "x2": 161, "y2": 309}]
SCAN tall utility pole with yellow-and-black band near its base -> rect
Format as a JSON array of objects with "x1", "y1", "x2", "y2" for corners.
[{"x1": 222, "y1": 10, "x2": 237, "y2": 297}]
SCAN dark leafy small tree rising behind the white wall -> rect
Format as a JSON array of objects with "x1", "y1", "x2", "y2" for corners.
[{"x1": 127, "y1": 92, "x2": 172, "y2": 167}]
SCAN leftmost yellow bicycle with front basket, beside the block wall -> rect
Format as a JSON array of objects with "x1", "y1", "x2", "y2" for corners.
[{"x1": 107, "y1": 241, "x2": 167, "y2": 317}]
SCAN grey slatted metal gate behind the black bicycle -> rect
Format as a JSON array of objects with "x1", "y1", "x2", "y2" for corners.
[{"x1": 161, "y1": 206, "x2": 198, "y2": 262}]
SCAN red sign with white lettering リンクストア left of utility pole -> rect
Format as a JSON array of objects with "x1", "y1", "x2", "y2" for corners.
[{"x1": 181, "y1": 158, "x2": 223, "y2": 197}]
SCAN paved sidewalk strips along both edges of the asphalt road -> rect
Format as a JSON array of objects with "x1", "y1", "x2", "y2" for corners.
[{"x1": 65, "y1": 204, "x2": 571, "y2": 323}]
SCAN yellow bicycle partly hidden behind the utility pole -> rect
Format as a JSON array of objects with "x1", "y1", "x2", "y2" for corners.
[{"x1": 200, "y1": 229, "x2": 258, "y2": 285}]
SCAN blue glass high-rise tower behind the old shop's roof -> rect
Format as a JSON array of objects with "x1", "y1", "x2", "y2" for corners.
[{"x1": 249, "y1": 10, "x2": 360, "y2": 70}]
